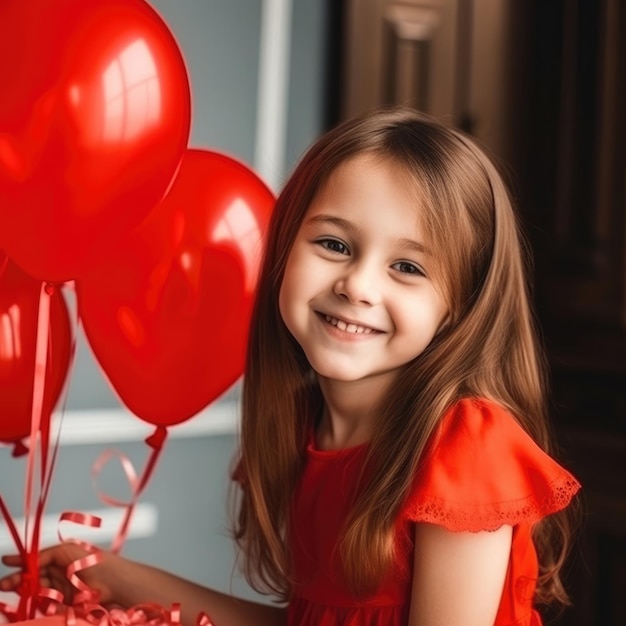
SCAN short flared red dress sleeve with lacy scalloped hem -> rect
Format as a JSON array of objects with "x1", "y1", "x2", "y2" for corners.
[{"x1": 404, "y1": 398, "x2": 580, "y2": 532}]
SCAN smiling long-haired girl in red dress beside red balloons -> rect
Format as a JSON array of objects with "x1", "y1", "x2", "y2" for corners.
[{"x1": 0, "y1": 109, "x2": 579, "y2": 626}]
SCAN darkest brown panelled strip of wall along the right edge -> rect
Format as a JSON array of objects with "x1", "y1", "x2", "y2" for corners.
[{"x1": 520, "y1": 0, "x2": 626, "y2": 626}]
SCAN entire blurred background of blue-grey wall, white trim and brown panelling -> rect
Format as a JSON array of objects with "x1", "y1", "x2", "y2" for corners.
[{"x1": 0, "y1": 0, "x2": 626, "y2": 626}]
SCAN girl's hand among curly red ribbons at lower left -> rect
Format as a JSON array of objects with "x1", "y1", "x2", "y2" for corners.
[{"x1": 0, "y1": 543, "x2": 117, "y2": 607}]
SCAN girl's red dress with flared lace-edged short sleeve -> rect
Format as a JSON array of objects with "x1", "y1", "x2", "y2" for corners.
[{"x1": 288, "y1": 400, "x2": 580, "y2": 626}]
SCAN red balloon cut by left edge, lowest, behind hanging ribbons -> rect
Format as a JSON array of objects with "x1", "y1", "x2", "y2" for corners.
[{"x1": 0, "y1": 261, "x2": 72, "y2": 443}]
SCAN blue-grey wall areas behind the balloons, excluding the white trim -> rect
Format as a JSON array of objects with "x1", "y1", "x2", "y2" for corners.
[{"x1": 0, "y1": 0, "x2": 326, "y2": 595}]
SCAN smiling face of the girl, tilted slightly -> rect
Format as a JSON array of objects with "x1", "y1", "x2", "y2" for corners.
[{"x1": 279, "y1": 155, "x2": 447, "y2": 384}]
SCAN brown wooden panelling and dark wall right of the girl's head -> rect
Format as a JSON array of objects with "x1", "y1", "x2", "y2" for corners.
[{"x1": 330, "y1": 0, "x2": 626, "y2": 626}]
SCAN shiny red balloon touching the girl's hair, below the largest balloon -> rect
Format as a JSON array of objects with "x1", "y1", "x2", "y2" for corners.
[{"x1": 76, "y1": 150, "x2": 274, "y2": 426}]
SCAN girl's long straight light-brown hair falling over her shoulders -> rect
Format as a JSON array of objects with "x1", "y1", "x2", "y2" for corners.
[{"x1": 235, "y1": 109, "x2": 569, "y2": 602}]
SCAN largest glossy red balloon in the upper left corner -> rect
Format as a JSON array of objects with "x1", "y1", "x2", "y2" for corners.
[{"x1": 0, "y1": 0, "x2": 191, "y2": 281}]
